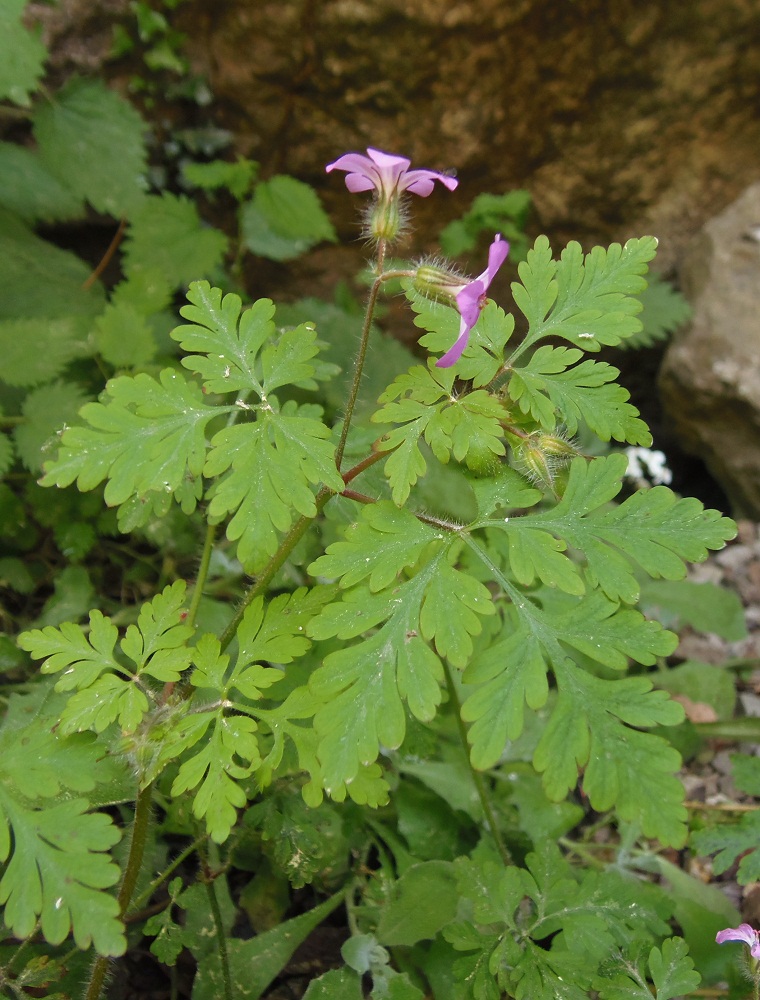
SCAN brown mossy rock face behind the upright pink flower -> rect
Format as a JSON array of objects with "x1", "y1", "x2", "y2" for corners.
[{"x1": 30, "y1": 0, "x2": 760, "y2": 270}]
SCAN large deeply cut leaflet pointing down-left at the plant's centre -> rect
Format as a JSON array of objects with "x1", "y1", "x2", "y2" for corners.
[{"x1": 308, "y1": 544, "x2": 493, "y2": 789}]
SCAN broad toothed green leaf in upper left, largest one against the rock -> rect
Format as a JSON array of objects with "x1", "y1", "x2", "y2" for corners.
[{"x1": 34, "y1": 79, "x2": 147, "y2": 218}]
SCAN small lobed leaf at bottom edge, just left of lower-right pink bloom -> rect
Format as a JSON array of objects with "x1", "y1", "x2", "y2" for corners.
[{"x1": 596, "y1": 938, "x2": 702, "y2": 1000}]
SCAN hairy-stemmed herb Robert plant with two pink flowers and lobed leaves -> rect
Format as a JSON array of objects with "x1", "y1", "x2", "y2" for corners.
[{"x1": 8, "y1": 143, "x2": 735, "y2": 1000}]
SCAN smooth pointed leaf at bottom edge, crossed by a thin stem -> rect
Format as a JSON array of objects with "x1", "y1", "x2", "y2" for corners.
[{"x1": 193, "y1": 892, "x2": 344, "y2": 1000}]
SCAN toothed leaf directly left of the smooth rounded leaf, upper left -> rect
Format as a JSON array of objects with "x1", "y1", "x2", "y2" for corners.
[{"x1": 124, "y1": 192, "x2": 227, "y2": 288}]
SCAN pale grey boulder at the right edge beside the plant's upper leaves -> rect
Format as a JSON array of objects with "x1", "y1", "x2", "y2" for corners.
[{"x1": 660, "y1": 184, "x2": 760, "y2": 520}]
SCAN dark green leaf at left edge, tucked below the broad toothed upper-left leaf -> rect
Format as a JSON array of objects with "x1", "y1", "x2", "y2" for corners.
[{"x1": 0, "y1": 143, "x2": 84, "y2": 223}]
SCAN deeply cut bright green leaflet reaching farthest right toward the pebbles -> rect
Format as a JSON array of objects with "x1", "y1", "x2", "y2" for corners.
[{"x1": 480, "y1": 455, "x2": 736, "y2": 603}]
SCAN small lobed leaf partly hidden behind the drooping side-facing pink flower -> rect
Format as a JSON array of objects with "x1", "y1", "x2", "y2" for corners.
[{"x1": 405, "y1": 285, "x2": 515, "y2": 389}]
